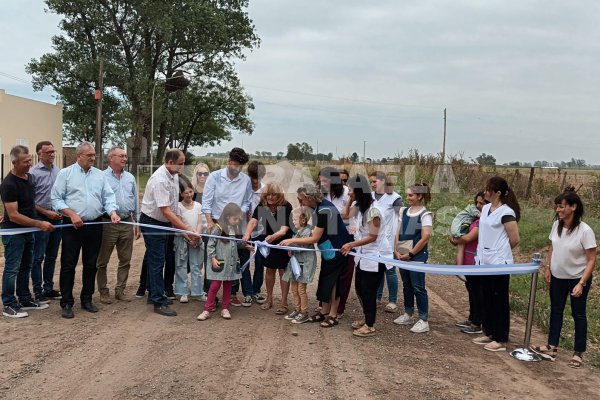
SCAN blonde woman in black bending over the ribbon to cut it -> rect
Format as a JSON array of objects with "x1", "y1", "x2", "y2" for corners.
[{"x1": 242, "y1": 183, "x2": 293, "y2": 315}]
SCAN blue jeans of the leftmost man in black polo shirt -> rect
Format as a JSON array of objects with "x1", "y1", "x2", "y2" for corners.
[{"x1": 2, "y1": 233, "x2": 34, "y2": 307}]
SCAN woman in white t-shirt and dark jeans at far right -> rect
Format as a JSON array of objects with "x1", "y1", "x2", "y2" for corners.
[{"x1": 531, "y1": 188, "x2": 597, "y2": 368}]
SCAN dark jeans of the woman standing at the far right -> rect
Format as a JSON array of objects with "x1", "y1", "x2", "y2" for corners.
[{"x1": 548, "y1": 276, "x2": 592, "y2": 353}]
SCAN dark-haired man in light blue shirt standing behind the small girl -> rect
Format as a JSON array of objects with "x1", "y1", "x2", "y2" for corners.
[{"x1": 202, "y1": 147, "x2": 254, "y2": 307}]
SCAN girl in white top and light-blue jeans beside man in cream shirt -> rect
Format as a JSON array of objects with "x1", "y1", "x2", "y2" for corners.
[{"x1": 174, "y1": 182, "x2": 204, "y2": 303}]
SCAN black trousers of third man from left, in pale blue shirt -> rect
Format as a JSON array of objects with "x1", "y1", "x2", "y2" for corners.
[{"x1": 59, "y1": 218, "x2": 102, "y2": 307}]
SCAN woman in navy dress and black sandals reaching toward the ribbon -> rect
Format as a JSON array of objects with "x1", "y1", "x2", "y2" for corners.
[{"x1": 281, "y1": 184, "x2": 352, "y2": 328}]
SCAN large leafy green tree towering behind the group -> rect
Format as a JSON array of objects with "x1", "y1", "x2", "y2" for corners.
[{"x1": 27, "y1": 0, "x2": 259, "y2": 170}]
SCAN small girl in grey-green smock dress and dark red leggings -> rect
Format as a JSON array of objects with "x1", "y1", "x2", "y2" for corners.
[{"x1": 198, "y1": 203, "x2": 242, "y2": 321}]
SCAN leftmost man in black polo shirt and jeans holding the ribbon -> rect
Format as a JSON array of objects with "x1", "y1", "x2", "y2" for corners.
[{"x1": 0, "y1": 146, "x2": 54, "y2": 318}]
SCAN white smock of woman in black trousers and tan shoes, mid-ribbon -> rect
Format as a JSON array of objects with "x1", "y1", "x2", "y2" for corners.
[{"x1": 354, "y1": 203, "x2": 391, "y2": 272}]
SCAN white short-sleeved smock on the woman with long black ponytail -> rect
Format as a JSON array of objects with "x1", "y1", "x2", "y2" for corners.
[{"x1": 475, "y1": 204, "x2": 516, "y2": 265}]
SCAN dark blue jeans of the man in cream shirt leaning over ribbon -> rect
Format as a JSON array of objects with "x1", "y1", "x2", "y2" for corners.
[{"x1": 140, "y1": 214, "x2": 169, "y2": 307}]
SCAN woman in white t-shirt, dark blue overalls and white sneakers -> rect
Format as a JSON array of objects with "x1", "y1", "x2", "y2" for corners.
[{"x1": 394, "y1": 183, "x2": 433, "y2": 333}]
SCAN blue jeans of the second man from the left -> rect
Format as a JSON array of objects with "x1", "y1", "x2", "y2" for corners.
[{"x1": 31, "y1": 215, "x2": 62, "y2": 296}]
